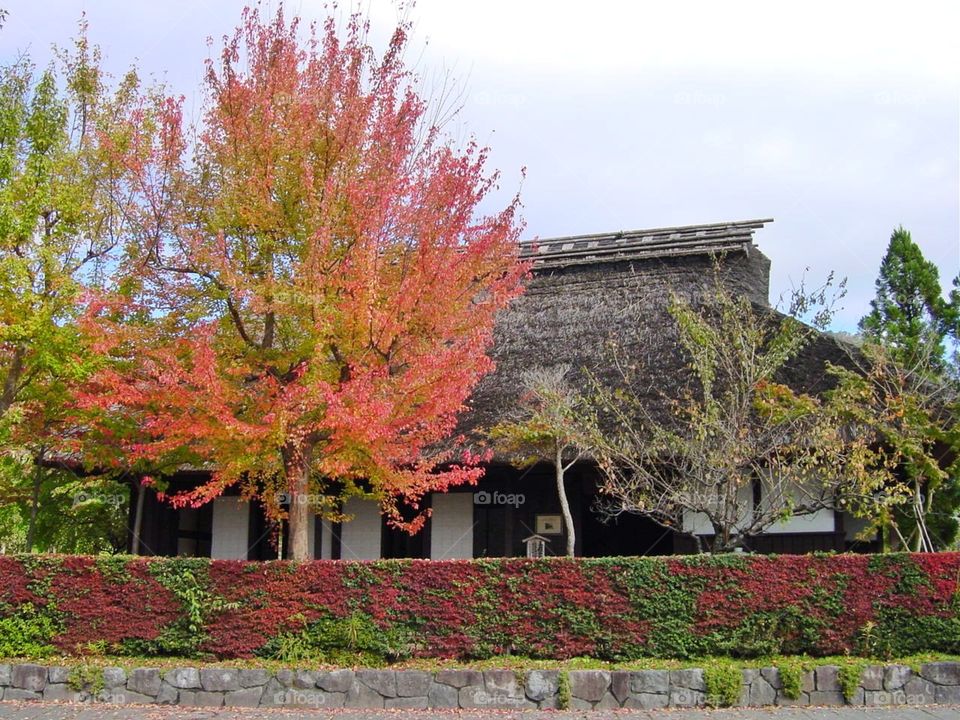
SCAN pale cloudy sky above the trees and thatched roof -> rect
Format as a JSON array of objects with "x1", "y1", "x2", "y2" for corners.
[{"x1": 0, "y1": 0, "x2": 960, "y2": 329}]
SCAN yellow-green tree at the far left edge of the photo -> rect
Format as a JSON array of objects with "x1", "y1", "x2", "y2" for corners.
[{"x1": 0, "y1": 23, "x2": 148, "y2": 551}]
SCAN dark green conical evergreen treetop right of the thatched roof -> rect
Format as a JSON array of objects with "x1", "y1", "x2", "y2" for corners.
[{"x1": 860, "y1": 226, "x2": 949, "y2": 372}]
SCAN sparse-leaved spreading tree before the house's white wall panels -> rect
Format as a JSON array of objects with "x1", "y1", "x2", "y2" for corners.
[{"x1": 598, "y1": 277, "x2": 875, "y2": 552}]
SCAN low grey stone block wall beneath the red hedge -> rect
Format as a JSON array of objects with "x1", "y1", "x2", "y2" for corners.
[{"x1": 0, "y1": 662, "x2": 960, "y2": 710}]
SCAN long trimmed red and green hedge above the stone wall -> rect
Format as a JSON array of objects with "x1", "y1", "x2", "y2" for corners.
[{"x1": 0, "y1": 553, "x2": 960, "y2": 662}]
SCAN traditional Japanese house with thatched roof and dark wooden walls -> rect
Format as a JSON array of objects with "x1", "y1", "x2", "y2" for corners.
[{"x1": 129, "y1": 220, "x2": 864, "y2": 559}]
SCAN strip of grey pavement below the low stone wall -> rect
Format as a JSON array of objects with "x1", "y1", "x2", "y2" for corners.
[{"x1": 0, "y1": 702, "x2": 960, "y2": 720}]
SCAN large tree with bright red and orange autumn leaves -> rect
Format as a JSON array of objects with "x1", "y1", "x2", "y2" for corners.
[{"x1": 81, "y1": 4, "x2": 526, "y2": 559}]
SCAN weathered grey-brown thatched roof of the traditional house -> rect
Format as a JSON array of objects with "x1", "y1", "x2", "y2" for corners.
[{"x1": 461, "y1": 220, "x2": 856, "y2": 433}]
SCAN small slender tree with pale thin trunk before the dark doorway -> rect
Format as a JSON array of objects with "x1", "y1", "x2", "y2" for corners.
[{"x1": 489, "y1": 365, "x2": 599, "y2": 557}]
